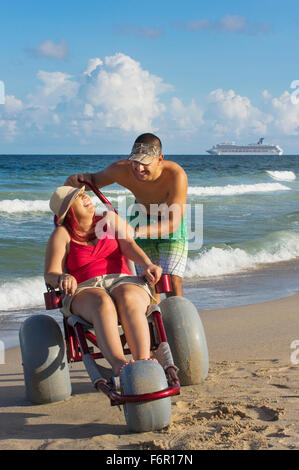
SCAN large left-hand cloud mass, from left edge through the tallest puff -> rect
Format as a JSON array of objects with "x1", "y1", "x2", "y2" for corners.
[{"x1": 0, "y1": 53, "x2": 171, "y2": 140}]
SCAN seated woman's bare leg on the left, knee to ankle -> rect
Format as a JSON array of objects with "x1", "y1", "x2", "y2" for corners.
[{"x1": 72, "y1": 289, "x2": 126, "y2": 375}]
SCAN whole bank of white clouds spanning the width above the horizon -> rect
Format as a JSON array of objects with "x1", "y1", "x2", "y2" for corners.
[{"x1": 0, "y1": 53, "x2": 299, "y2": 149}]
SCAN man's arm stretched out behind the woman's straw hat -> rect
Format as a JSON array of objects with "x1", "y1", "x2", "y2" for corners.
[{"x1": 64, "y1": 161, "x2": 124, "y2": 189}]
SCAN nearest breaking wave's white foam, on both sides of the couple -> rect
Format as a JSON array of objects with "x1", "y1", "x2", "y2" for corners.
[{"x1": 0, "y1": 231, "x2": 299, "y2": 311}]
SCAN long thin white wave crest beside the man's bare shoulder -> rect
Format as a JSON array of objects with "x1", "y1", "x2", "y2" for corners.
[{"x1": 188, "y1": 183, "x2": 291, "y2": 196}]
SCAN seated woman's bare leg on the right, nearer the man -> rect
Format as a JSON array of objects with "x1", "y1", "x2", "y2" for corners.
[{"x1": 111, "y1": 284, "x2": 150, "y2": 360}]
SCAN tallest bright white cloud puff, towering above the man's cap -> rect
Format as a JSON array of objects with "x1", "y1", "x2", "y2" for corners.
[{"x1": 81, "y1": 53, "x2": 171, "y2": 132}]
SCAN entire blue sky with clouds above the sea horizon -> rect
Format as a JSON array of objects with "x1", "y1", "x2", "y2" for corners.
[{"x1": 0, "y1": 0, "x2": 299, "y2": 155}]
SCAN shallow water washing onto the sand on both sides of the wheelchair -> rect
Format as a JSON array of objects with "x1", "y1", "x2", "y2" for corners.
[{"x1": 0, "y1": 258, "x2": 299, "y2": 350}]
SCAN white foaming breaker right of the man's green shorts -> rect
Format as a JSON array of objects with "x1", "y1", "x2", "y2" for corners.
[{"x1": 184, "y1": 232, "x2": 299, "y2": 278}]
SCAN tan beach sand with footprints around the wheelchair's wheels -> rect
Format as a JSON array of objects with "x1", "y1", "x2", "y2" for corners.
[{"x1": 0, "y1": 294, "x2": 299, "y2": 451}]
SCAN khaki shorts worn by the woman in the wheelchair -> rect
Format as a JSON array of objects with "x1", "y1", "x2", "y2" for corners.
[{"x1": 60, "y1": 274, "x2": 156, "y2": 317}]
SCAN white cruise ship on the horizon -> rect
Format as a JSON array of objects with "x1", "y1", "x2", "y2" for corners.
[{"x1": 207, "y1": 137, "x2": 283, "y2": 155}]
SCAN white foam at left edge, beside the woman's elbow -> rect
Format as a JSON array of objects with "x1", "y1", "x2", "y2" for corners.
[{"x1": 0, "y1": 276, "x2": 46, "y2": 310}]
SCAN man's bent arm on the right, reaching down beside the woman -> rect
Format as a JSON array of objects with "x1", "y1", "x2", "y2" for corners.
[{"x1": 136, "y1": 168, "x2": 188, "y2": 238}]
